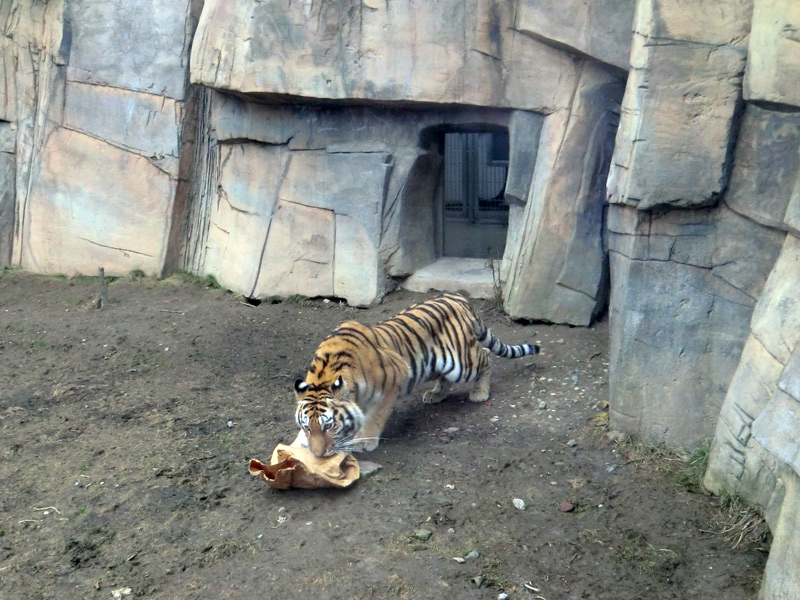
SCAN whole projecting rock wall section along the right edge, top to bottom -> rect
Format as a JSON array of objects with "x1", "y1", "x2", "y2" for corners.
[{"x1": 608, "y1": 0, "x2": 800, "y2": 599}]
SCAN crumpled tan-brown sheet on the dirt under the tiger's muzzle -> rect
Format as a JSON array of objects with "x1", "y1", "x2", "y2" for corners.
[{"x1": 250, "y1": 441, "x2": 360, "y2": 490}]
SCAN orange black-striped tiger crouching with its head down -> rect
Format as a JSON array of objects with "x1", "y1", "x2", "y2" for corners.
[{"x1": 294, "y1": 293, "x2": 539, "y2": 458}]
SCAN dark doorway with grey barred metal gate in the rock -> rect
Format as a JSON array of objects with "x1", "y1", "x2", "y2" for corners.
[{"x1": 440, "y1": 130, "x2": 509, "y2": 260}]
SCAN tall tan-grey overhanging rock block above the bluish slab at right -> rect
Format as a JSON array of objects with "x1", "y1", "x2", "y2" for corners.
[{"x1": 608, "y1": 0, "x2": 750, "y2": 210}]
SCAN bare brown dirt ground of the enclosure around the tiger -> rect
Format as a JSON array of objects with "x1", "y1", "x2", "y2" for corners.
[{"x1": 0, "y1": 271, "x2": 766, "y2": 600}]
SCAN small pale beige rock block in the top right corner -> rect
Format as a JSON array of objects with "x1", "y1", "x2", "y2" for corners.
[{"x1": 744, "y1": 0, "x2": 800, "y2": 107}]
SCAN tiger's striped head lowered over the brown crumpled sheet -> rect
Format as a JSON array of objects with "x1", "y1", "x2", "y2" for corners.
[{"x1": 294, "y1": 375, "x2": 364, "y2": 458}]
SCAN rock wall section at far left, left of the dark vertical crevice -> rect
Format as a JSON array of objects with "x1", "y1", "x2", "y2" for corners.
[{"x1": 0, "y1": 0, "x2": 197, "y2": 275}]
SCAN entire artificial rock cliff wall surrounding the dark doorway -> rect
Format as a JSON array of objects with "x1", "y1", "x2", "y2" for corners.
[{"x1": 0, "y1": 0, "x2": 800, "y2": 598}]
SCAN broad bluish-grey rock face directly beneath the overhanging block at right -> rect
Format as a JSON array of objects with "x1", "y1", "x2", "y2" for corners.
[{"x1": 608, "y1": 206, "x2": 784, "y2": 447}]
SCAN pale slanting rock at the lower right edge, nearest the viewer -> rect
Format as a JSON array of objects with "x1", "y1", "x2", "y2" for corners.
[{"x1": 705, "y1": 235, "x2": 800, "y2": 600}]
